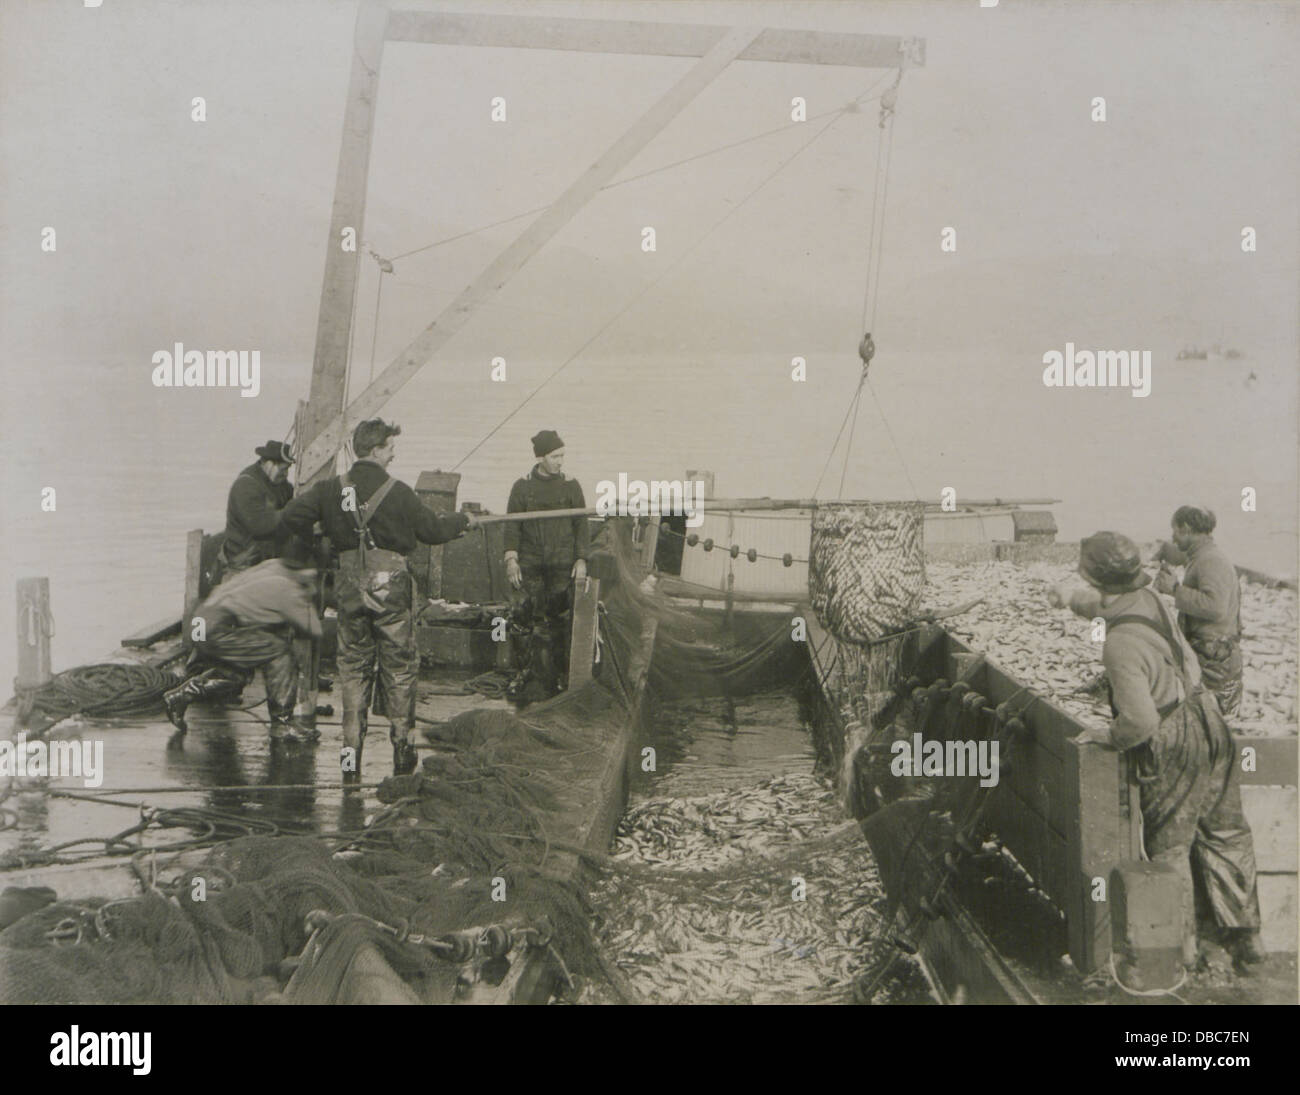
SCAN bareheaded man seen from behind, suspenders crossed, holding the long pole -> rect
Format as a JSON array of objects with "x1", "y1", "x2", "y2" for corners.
[{"x1": 283, "y1": 419, "x2": 477, "y2": 787}]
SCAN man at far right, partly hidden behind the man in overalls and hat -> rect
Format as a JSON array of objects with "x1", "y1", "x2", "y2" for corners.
[{"x1": 1156, "y1": 506, "x2": 1242, "y2": 718}]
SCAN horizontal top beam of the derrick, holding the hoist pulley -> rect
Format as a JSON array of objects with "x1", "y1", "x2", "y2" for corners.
[{"x1": 387, "y1": 10, "x2": 926, "y2": 69}]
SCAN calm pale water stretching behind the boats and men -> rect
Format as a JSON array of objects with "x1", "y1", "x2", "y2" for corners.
[{"x1": 0, "y1": 354, "x2": 1296, "y2": 680}]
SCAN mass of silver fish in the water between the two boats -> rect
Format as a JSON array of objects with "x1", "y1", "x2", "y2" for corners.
[{"x1": 593, "y1": 774, "x2": 904, "y2": 1004}]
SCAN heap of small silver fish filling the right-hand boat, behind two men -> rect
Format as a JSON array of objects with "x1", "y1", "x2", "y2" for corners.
[{"x1": 926, "y1": 562, "x2": 1300, "y2": 737}]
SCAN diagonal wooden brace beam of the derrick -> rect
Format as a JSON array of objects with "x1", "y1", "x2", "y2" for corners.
[{"x1": 299, "y1": 27, "x2": 761, "y2": 481}]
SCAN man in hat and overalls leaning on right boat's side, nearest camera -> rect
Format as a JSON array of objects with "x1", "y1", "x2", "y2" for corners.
[{"x1": 1049, "y1": 532, "x2": 1264, "y2": 973}]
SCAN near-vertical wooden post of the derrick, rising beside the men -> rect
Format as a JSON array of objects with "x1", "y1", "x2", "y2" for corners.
[{"x1": 296, "y1": 0, "x2": 389, "y2": 481}]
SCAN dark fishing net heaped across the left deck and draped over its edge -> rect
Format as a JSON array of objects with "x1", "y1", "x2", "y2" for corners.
[{"x1": 0, "y1": 523, "x2": 816, "y2": 1004}]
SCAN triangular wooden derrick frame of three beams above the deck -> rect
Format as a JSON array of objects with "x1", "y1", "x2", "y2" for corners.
[{"x1": 296, "y1": 0, "x2": 926, "y2": 489}]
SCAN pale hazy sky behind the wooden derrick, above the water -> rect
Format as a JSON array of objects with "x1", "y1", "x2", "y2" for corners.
[{"x1": 0, "y1": 0, "x2": 1300, "y2": 363}]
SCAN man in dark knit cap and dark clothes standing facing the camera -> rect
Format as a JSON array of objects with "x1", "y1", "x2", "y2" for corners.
[{"x1": 506, "y1": 429, "x2": 589, "y2": 706}]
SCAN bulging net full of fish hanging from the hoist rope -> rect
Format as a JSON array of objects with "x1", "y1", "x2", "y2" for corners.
[{"x1": 809, "y1": 502, "x2": 926, "y2": 642}]
